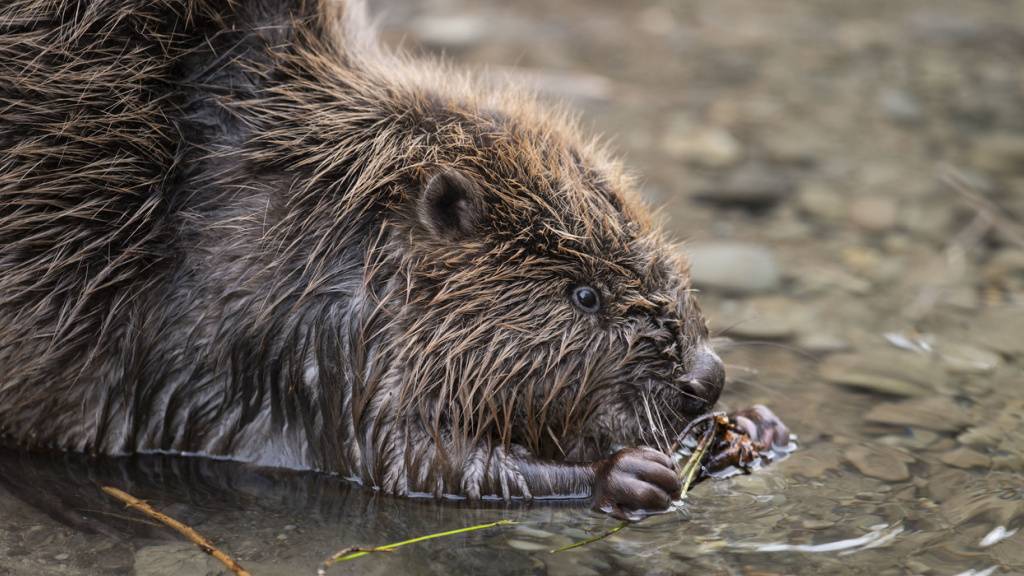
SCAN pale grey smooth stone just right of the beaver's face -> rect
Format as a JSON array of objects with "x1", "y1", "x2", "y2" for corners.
[{"x1": 686, "y1": 242, "x2": 781, "y2": 294}]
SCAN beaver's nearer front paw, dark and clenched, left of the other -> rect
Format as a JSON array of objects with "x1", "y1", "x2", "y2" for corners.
[{"x1": 594, "y1": 448, "x2": 681, "y2": 520}]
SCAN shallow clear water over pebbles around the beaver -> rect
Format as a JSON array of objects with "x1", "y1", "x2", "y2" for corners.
[{"x1": 0, "y1": 0, "x2": 1024, "y2": 576}]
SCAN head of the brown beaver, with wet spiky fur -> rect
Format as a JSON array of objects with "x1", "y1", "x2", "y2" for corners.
[{"x1": 380, "y1": 120, "x2": 724, "y2": 460}]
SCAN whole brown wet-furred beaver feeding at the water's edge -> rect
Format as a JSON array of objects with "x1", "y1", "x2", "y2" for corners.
[{"x1": 0, "y1": 0, "x2": 787, "y2": 515}]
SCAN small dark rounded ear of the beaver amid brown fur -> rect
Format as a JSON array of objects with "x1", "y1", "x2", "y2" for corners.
[{"x1": 419, "y1": 170, "x2": 481, "y2": 239}]
